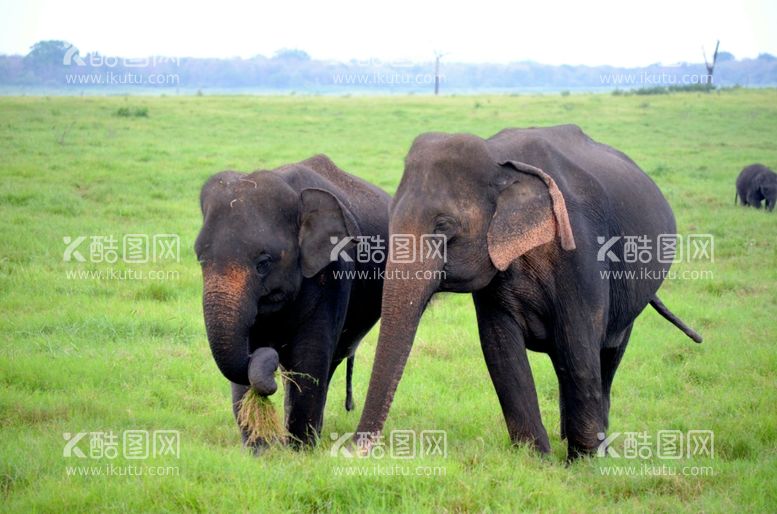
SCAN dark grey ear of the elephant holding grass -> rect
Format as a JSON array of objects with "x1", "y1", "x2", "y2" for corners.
[{"x1": 299, "y1": 188, "x2": 361, "y2": 278}]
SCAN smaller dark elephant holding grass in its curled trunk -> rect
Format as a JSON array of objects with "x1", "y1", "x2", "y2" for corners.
[{"x1": 195, "y1": 155, "x2": 390, "y2": 452}]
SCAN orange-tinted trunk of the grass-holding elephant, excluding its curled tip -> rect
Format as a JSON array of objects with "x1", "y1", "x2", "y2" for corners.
[{"x1": 203, "y1": 267, "x2": 256, "y2": 385}]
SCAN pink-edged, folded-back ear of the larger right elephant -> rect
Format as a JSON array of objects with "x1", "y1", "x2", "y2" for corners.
[{"x1": 488, "y1": 161, "x2": 575, "y2": 271}]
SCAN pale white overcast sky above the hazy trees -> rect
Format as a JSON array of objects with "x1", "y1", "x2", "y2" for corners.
[{"x1": 0, "y1": 0, "x2": 777, "y2": 66}]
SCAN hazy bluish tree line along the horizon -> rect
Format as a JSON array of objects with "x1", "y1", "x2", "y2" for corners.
[{"x1": 0, "y1": 41, "x2": 777, "y2": 94}]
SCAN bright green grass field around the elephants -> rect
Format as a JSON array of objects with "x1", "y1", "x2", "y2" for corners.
[{"x1": 0, "y1": 90, "x2": 777, "y2": 512}]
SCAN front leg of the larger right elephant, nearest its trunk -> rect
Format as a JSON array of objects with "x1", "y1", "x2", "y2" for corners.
[{"x1": 472, "y1": 293, "x2": 550, "y2": 453}]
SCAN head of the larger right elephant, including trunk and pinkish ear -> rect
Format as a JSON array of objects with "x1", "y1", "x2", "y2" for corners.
[{"x1": 358, "y1": 134, "x2": 575, "y2": 433}]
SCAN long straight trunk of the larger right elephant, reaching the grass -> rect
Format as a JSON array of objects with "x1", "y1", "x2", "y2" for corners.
[{"x1": 358, "y1": 256, "x2": 442, "y2": 434}]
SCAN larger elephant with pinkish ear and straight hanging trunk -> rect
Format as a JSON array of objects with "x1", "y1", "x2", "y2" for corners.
[{"x1": 357, "y1": 125, "x2": 701, "y2": 458}]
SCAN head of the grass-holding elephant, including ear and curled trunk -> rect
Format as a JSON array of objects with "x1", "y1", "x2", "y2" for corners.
[{"x1": 195, "y1": 171, "x2": 357, "y2": 386}]
